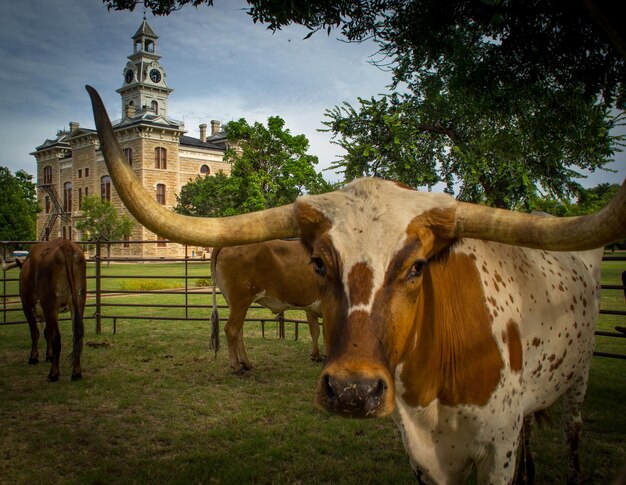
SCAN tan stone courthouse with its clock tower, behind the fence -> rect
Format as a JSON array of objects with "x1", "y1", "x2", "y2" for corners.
[{"x1": 32, "y1": 17, "x2": 231, "y2": 257}]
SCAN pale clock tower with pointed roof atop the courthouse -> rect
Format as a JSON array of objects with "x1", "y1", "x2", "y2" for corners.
[{"x1": 117, "y1": 14, "x2": 173, "y2": 122}]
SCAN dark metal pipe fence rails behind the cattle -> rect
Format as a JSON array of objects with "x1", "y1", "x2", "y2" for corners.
[{"x1": 0, "y1": 241, "x2": 626, "y2": 359}]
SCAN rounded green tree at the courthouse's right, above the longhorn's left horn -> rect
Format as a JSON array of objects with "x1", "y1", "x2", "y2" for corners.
[{"x1": 174, "y1": 116, "x2": 332, "y2": 216}]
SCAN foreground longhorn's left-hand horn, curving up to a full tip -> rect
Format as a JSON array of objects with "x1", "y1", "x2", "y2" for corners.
[{"x1": 85, "y1": 86, "x2": 299, "y2": 246}]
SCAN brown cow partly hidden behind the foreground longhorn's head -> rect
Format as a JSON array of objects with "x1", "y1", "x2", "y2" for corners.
[{"x1": 211, "y1": 239, "x2": 323, "y2": 372}]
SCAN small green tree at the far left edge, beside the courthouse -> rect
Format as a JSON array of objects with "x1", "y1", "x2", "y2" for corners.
[{"x1": 0, "y1": 167, "x2": 41, "y2": 241}]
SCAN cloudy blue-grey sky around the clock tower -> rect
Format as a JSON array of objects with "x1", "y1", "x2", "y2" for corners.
[{"x1": 0, "y1": 0, "x2": 626, "y2": 185}]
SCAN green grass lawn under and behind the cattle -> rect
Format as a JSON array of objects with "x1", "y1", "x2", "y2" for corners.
[{"x1": 0, "y1": 262, "x2": 626, "y2": 484}]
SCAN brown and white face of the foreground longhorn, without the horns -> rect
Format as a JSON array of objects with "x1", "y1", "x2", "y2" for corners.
[{"x1": 296, "y1": 179, "x2": 456, "y2": 417}]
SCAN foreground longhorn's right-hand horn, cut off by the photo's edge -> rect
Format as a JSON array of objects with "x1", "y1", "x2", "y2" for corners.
[{"x1": 454, "y1": 180, "x2": 626, "y2": 251}]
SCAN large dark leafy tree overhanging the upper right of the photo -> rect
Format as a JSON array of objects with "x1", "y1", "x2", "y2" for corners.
[{"x1": 104, "y1": 0, "x2": 626, "y2": 208}]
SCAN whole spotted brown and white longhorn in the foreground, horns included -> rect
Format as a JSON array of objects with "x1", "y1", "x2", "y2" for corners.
[{"x1": 88, "y1": 88, "x2": 626, "y2": 483}]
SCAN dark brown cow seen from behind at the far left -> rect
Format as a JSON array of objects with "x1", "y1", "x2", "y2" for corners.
[{"x1": 3, "y1": 238, "x2": 87, "y2": 382}]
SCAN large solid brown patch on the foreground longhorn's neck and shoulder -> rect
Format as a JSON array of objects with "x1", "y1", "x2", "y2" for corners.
[{"x1": 400, "y1": 253, "x2": 503, "y2": 406}]
